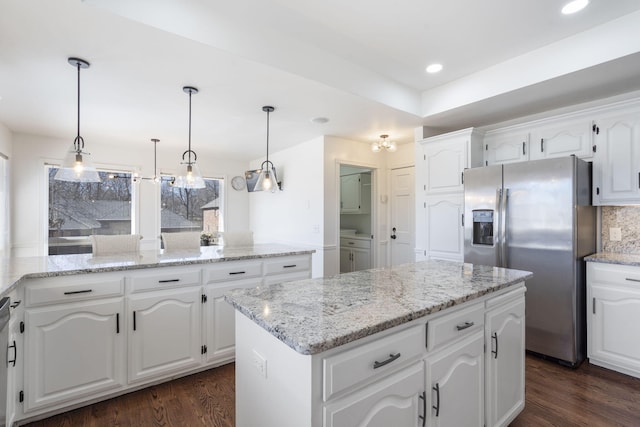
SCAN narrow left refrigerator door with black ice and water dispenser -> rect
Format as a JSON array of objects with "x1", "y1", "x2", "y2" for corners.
[{"x1": 464, "y1": 165, "x2": 502, "y2": 265}]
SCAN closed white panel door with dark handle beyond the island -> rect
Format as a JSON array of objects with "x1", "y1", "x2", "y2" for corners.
[{"x1": 390, "y1": 167, "x2": 415, "y2": 265}]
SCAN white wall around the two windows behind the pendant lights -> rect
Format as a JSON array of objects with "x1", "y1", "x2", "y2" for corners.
[{"x1": 10, "y1": 134, "x2": 249, "y2": 256}]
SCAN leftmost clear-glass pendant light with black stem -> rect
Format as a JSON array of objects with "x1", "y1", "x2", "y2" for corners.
[{"x1": 54, "y1": 58, "x2": 100, "y2": 182}]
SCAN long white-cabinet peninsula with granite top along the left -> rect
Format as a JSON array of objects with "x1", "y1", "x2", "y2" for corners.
[{"x1": 0, "y1": 244, "x2": 313, "y2": 425}]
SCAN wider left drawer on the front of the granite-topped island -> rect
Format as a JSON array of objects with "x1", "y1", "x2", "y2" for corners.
[{"x1": 322, "y1": 326, "x2": 425, "y2": 402}]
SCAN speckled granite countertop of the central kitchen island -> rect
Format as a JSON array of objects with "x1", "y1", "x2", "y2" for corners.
[{"x1": 225, "y1": 261, "x2": 533, "y2": 354}]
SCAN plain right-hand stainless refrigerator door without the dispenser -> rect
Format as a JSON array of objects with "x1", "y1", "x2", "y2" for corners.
[{"x1": 504, "y1": 157, "x2": 584, "y2": 364}]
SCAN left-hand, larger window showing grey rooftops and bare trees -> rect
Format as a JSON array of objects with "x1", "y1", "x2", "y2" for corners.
[{"x1": 48, "y1": 167, "x2": 132, "y2": 255}]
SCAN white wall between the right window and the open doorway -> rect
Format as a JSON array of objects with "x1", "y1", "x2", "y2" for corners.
[{"x1": 249, "y1": 137, "x2": 324, "y2": 277}]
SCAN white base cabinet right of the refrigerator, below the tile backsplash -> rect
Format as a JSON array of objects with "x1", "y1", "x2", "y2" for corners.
[{"x1": 587, "y1": 262, "x2": 640, "y2": 378}]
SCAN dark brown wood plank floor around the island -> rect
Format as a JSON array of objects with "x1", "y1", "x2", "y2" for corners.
[{"x1": 22, "y1": 356, "x2": 640, "y2": 427}]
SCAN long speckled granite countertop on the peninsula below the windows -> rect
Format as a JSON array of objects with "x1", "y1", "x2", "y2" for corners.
[{"x1": 0, "y1": 244, "x2": 315, "y2": 296}]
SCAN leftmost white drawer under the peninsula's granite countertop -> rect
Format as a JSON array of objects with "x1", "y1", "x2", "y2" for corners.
[{"x1": 24, "y1": 274, "x2": 124, "y2": 307}]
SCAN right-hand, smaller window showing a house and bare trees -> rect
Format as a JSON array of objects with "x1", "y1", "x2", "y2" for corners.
[{"x1": 160, "y1": 178, "x2": 224, "y2": 244}]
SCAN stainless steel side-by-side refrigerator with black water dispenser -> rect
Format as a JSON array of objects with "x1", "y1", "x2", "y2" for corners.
[{"x1": 464, "y1": 156, "x2": 596, "y2": 366}]
